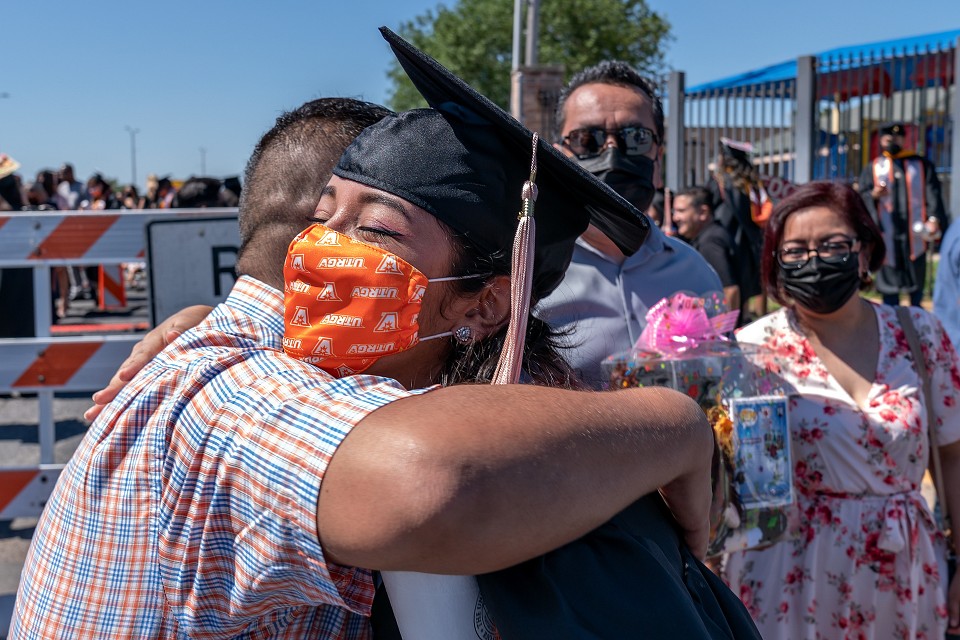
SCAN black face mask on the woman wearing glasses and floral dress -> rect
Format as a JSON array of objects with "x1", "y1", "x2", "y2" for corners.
[{"x1": 780, "y1": 252, "x2": 860, "y2": 314}]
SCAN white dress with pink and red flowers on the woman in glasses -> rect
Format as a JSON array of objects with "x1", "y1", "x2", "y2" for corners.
[{"x1": 724, "y1": 305, "x2": 960, "y2": 640}]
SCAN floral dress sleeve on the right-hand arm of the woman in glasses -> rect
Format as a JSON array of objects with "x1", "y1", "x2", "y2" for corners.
[{"x1": 911, "y1": 308, "x2": 960, "y2": 445}]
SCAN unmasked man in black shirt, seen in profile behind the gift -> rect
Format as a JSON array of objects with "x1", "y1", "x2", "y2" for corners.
[{"x1": 673, "y1": 187, "x2": 740, "y2": 316}]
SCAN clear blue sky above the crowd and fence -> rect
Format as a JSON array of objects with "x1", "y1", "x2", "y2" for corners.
[{"x1": 0, "y1": 0, "x2": 960, "y2": 190}]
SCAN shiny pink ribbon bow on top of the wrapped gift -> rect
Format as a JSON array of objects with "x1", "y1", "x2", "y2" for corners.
[{"x1": 634, "y1": 293, "x2": 740, "y2": 355}]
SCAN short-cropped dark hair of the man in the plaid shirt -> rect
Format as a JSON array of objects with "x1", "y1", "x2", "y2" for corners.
[{"x1": 237, "y1": 98, "x2": 393, "y2": 288}]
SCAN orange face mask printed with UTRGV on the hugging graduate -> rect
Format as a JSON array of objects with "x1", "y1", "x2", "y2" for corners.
[{"x1": 283, "y1": 224, "x2": 476, "y2": 378}]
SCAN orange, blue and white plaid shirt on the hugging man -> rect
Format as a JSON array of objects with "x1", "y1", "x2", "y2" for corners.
[{"x1": 11, "y1": 277, "x2": 420, "y2": 640}]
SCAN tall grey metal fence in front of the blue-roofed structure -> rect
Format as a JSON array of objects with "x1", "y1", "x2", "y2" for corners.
[{"x1": 666, "y1": 33, "x2": 960, "y2": 212}]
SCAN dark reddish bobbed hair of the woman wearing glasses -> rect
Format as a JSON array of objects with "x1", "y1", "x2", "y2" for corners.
[{"x1": 761, "y1": 180, "x2": 886, "y2": 305}]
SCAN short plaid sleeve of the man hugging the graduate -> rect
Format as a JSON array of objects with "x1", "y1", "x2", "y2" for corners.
[{"x1": 161, "y1": 365, "x2": 430, "y2": 619}]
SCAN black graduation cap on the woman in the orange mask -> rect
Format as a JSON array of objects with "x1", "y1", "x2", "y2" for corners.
[{"x1": 334, "y1": 27, "x2": 653, "y2": 297}]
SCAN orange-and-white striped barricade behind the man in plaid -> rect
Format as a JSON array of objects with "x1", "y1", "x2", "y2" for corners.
[{"x1": 0, "y1": 209, "x2": 236, "y2": 520}]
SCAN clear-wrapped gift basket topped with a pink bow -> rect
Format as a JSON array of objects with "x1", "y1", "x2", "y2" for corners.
[{"x1": 602, "y1": 293, "x2": 794, "y2": 556}]
